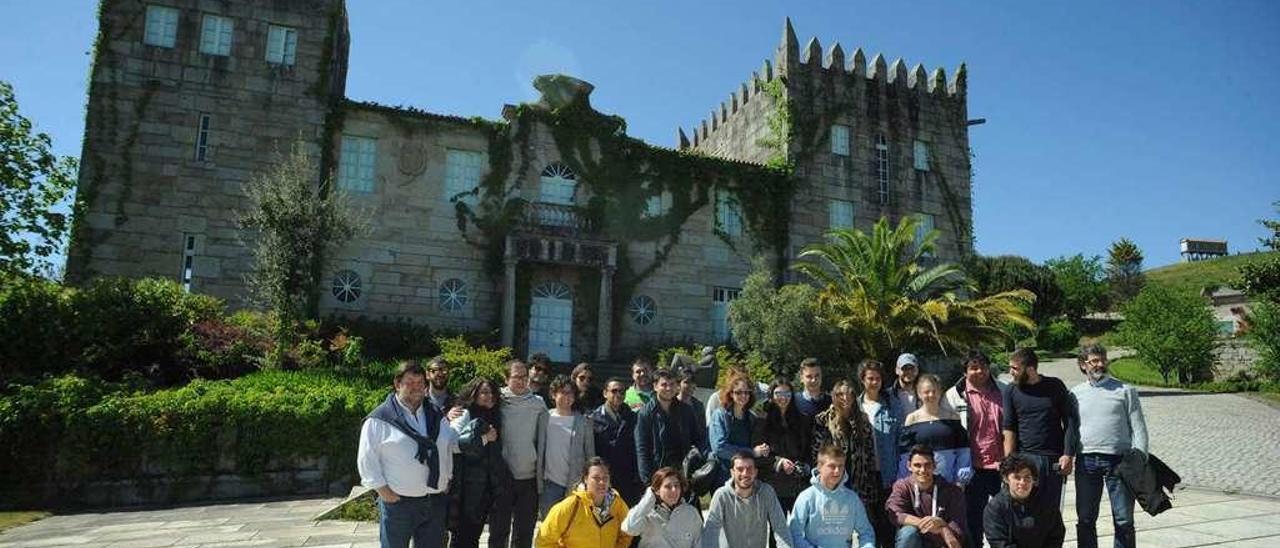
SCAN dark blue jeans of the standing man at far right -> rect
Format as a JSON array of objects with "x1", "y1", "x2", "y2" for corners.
[{"x1": 1075, "y1": 453, "x2": 1137, "y2": 548}]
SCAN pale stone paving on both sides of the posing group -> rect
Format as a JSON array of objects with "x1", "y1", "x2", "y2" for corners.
[{"x1": 10, "y1": 360, "x2": 1280, "y2": 548}]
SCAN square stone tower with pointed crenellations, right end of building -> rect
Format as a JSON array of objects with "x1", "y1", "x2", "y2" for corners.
[{"x1": 677, "y1": 18, "x2": 973, "y2": 260}]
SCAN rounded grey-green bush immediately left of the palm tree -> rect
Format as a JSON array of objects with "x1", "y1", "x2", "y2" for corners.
[{"x1": 728, "y1": 261, "x2": 850, "y2": 373}]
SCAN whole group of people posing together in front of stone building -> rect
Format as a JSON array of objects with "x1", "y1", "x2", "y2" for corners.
[{"x1": 357, "y1": 344, "x2": 1147, "y2": 548}]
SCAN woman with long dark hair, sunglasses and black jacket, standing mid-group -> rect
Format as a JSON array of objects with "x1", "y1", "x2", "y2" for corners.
[{"x1": 762, "y1": 376, "x2": 808, "y2": 512}]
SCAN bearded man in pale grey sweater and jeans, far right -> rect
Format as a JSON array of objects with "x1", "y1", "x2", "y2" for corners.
[{"x1": 1071, "y1": 344, "x2": 1147, "y2": 548}]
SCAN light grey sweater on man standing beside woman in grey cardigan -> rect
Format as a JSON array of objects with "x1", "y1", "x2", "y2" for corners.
[{"x1": 498, "y1": 388, "x2": 548, "y2": 483}]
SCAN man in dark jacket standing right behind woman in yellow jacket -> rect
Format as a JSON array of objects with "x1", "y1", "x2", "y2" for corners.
[{"x1": 591, "y1": 378, "x2": 643, "y2": 507}]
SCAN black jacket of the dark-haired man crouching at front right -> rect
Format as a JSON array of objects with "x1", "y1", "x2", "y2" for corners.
[{"x1": 982, "y1": 487, "x2": 1066, "y2": 548}]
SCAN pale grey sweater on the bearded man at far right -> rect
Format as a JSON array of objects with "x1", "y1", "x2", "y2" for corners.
[{"x1": 1071, "y1": 376, "x2": 1147, "y2": 455}]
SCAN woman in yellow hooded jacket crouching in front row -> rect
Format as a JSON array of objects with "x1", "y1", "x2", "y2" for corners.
[{"x1": 536, "y1": 457, "x2": 631, "y2": 548}]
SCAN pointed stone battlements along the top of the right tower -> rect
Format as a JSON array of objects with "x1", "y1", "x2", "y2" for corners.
[{"x1": 676, "y1": 18, "x2": 968, "y2": 150}]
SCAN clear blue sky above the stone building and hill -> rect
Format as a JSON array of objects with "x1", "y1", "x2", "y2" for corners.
[{"x1": 0, "y1": 0, "x2": 1280, "y2": 268}]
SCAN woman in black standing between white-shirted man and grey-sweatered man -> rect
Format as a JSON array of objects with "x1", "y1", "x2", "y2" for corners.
[{"x1": 449, "y1": 378, "x2": 511, "y2": 548}]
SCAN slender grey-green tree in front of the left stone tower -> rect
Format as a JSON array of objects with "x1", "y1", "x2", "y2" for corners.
[{"x1": 241, "y1": 141, "x2": 362, "y2": 366}]
